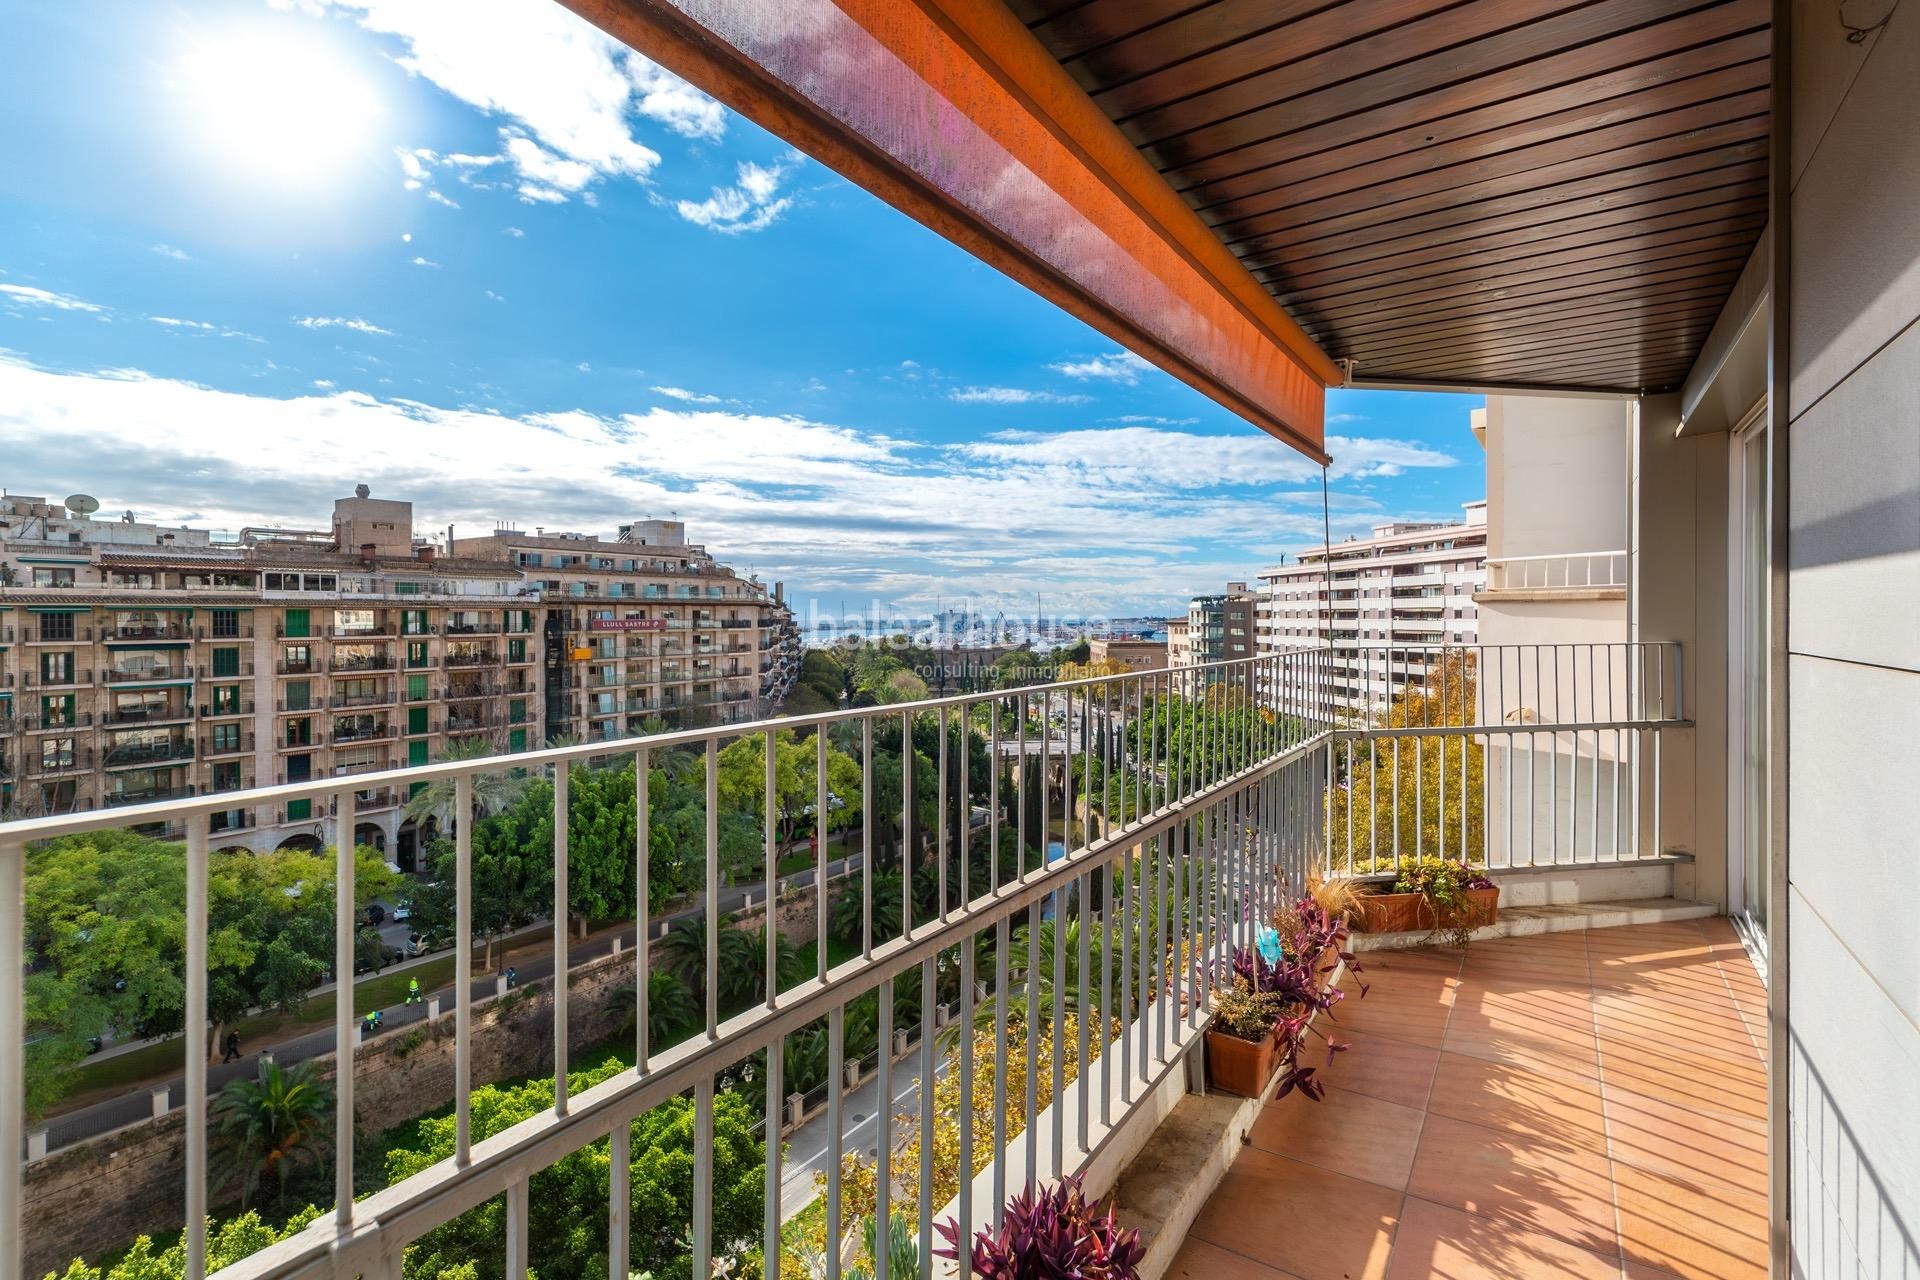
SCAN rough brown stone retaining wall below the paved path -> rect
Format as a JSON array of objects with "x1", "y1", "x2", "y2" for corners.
[{"x1": 23, "y1": 948, "x2": 637, "y2": 1280}]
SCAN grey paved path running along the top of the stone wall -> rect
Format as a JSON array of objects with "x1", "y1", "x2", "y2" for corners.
[{"x1": 44, "y1": 854, "x2": 860, "y2": 1151}]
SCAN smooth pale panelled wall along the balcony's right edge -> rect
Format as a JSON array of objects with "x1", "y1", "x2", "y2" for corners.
[{"x1": 1774, "y1": 0, "x2": 1920, "y2": 1278}]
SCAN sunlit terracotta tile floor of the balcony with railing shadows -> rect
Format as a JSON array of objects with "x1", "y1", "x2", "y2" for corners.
[{"x1": 1171, "y1": 919, "x2": 1766, "y2": 1280}]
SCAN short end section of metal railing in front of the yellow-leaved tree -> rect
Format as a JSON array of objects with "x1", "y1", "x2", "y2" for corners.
[{"x1": 1327, "y1": 641, "x2": 1690, "y2": 873}]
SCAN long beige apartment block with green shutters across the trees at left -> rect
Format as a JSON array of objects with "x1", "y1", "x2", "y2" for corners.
[{"x1": 0, "y1": 486, "x2": 797, "y2": 865}]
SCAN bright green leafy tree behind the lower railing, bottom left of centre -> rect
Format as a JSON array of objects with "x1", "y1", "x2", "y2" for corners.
[{"x1": 386, "y1": 1059, "x2": 766, "y2": 1280}]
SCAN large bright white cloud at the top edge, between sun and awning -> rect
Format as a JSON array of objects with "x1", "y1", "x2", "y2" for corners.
[{"x1": 294, "y1": 0, "x2": 728, "y2": 200}]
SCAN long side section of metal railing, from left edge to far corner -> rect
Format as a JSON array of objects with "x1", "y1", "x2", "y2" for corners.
[{"x1": 0, "y1": 651, "x2": 1332, "y2": 1280}]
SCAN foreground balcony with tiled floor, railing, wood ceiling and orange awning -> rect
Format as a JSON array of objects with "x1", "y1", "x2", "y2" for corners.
[{"x1": 0, "y1": 0, "x2": 1920, "y2": 1280}]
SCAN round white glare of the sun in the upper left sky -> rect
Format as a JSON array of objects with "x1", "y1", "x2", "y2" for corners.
[{"x1": 173, "y1": 29, "x2": 386, "y2": 188}]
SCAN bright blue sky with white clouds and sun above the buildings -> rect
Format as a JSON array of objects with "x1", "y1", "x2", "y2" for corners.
[{"x1": 0, "y1": 0, "x2": 1484, "y2": 614}]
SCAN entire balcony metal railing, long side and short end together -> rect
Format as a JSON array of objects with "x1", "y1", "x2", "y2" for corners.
[{"x1": 0, "y1": 643, "x2": 1686, "y2": 1280}]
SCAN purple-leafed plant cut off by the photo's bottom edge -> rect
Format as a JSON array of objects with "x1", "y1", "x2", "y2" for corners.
[{"x1": 933, "y1": 1176, "x2": 1146, "y2": 1280}]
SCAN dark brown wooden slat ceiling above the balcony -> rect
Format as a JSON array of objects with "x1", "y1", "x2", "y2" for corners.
[{"x1": 1008, "y1": 0, "x2": 1768, "y2": 391}]
